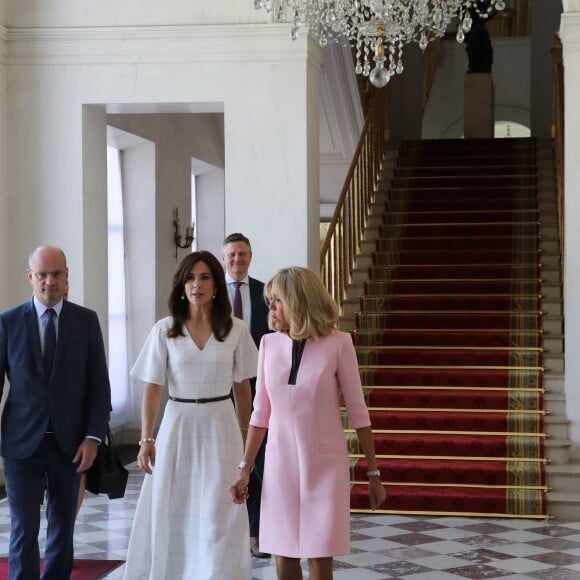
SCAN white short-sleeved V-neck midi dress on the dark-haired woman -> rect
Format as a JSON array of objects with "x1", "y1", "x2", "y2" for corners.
[{"x1": 124, "y1": 317, "x2": 257, "y2": 580}]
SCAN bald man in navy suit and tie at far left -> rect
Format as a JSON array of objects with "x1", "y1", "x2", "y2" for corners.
[{"x1": 0, "y1": 246, "x2": 111, "y2": 580}]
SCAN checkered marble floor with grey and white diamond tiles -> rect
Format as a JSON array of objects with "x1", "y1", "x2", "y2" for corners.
[{"x1": 0, "y1": 464, "x2": 580, "y2": 580}]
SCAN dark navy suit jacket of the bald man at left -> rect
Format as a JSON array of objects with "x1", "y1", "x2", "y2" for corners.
[{"x1": 0, "y1": 300, "x2": 111, "y2": 460}]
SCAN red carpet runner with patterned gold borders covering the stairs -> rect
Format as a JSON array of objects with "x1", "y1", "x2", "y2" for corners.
[{"x1": 345, "y1": 139, "x2": 546, "y2": 517}]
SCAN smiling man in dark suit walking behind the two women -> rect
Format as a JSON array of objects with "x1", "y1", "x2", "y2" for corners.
[{"x1": 222, "y1": 233, "x2": 270, "y2": 558}]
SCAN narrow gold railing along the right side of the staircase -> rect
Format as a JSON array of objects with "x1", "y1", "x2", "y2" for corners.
[{"x1": 552, "y1": 39, "x2": 564, "y2": 290}]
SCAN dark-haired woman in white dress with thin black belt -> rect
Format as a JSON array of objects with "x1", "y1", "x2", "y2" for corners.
[{"x1": 125, "y1": 251, "x2": 257, "y2": 580}]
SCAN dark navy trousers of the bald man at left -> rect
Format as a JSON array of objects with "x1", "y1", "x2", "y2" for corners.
[{"x1": 4, "y1": 434, "x2": 80, "y2": 580}]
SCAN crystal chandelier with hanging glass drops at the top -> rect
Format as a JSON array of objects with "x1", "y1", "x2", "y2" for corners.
[{"x1": 254, "y1": 0, "x2": 505, "y2": 87}]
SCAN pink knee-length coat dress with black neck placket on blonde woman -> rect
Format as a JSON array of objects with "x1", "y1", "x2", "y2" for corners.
[{"x1": 250, "y1": 331, "x2": 371, "y2": 558}]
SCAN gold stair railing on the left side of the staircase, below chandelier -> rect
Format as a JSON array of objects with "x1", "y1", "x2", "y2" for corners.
[{"x1": 320, "y1": 87, "x2": 388, "y2": 314}]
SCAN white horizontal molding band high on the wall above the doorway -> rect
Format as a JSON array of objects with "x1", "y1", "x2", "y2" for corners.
[{"x1": 5, "y1": 24, "x2": 322, "y2": 67}]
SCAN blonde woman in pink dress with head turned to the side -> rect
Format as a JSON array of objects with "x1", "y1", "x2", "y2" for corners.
[{"x1": 230, "y1": 267, "x2": 386, "y2": 580}]
